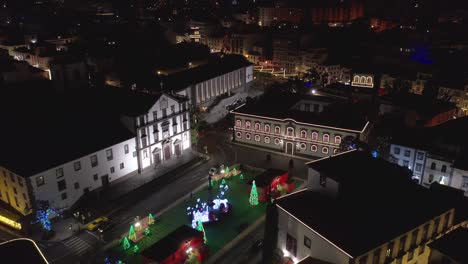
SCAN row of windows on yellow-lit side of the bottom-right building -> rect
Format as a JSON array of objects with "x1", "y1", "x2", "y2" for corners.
[{"x1": 358, "y1": 213, "x2": 450, "y2": 264}]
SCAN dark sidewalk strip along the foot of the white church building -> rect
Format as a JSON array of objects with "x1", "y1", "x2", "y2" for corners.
[{"x1": 31, "y1": 150, "x2": 206, "y2": 242}]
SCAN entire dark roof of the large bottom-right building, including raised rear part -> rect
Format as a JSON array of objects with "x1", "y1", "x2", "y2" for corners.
[{"x1": 277, "y1": 151, "x2": 452, "y2": 257}]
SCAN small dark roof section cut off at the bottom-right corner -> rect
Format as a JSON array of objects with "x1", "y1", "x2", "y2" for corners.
[{"x1": 429, "y1": 227, "x2": 468, "y2": 263}]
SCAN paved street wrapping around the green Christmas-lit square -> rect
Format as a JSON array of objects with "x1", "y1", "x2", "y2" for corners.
[{"x1": 22, "y1": 120, "x2": 307, "y2": 264}]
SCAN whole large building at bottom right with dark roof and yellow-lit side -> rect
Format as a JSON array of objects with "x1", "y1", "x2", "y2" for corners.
[{"x1": 275, "y1": 150, "x2": 459, "y2": 264}]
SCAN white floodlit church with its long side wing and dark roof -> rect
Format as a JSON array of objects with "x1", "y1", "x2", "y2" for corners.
[{"x1": 0, "y1": 87, "x2": 191, "y2": 215}]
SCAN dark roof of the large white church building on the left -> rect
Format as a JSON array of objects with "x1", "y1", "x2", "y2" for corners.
[{"x1": 0, "y1": 81, "x2": 168, "y2": 177}]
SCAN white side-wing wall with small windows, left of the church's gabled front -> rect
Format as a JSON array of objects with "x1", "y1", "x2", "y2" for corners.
[{"x1": 30, "y1": 138, "x2": 138, "y2": 208}]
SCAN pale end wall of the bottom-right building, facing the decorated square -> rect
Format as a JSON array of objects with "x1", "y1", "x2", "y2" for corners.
[{"x1": 277, "y1": 208, "x2": 350, "y2": 264}]
